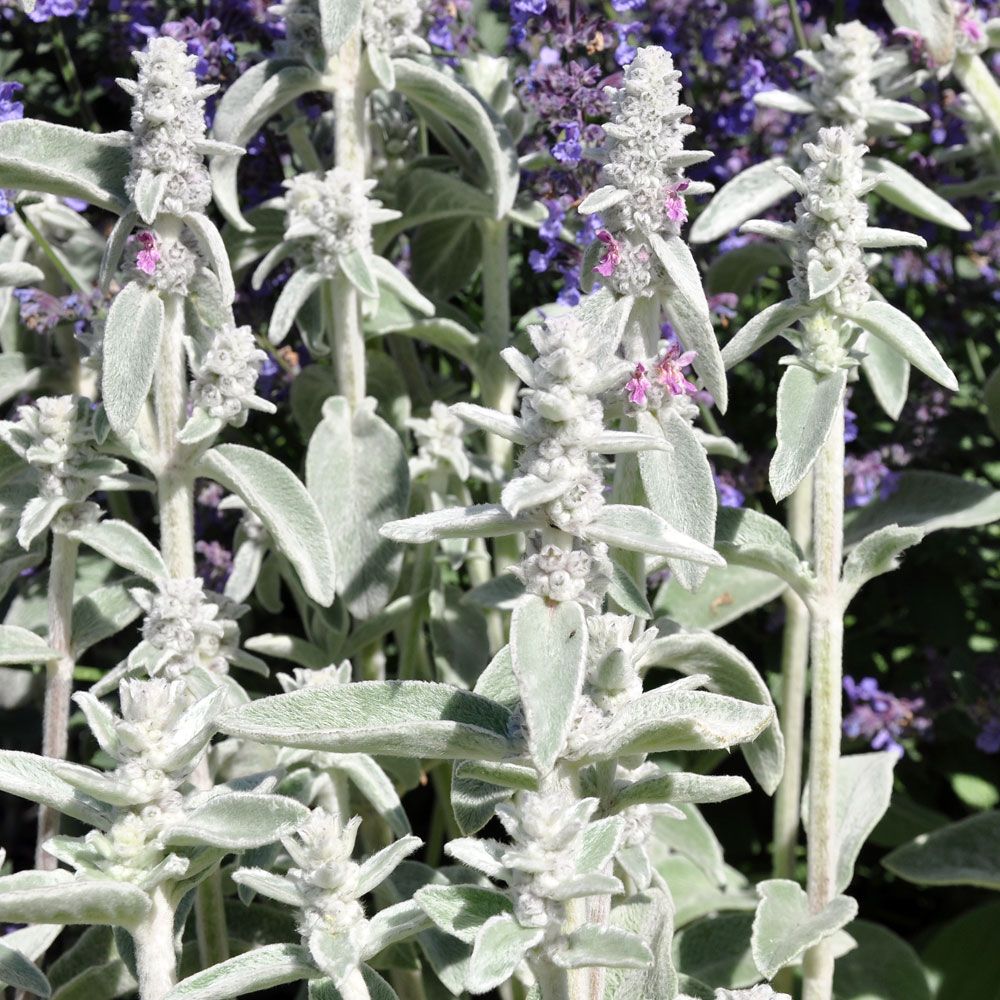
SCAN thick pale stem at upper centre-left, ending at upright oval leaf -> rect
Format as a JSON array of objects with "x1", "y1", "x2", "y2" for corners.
[{"x1": 327, "y1": 29, "x2": 368, "y2": 409}]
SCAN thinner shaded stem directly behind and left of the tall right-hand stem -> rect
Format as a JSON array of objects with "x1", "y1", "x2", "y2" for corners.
[{"x1": 772, "y1": 473, "x2": 813, "y2": 993}]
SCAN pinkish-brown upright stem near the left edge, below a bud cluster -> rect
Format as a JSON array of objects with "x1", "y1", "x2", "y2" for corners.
[{"x1": 35, "y1": 531, "x2": 80, "y2": 870}]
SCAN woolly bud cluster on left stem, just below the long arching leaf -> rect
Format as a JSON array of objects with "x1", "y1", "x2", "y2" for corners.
[{"x1": 131, "y1": 578, "x2": 245, "y2": 680}]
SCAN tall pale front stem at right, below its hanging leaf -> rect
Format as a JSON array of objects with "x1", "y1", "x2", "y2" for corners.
[{"x1": 803, "y1": 398, "x2": 844, "y2": 1000}]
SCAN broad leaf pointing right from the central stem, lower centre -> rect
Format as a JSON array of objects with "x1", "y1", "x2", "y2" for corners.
[{"x1": 583, "y1": 679, "x2": 774, "y2": 761}]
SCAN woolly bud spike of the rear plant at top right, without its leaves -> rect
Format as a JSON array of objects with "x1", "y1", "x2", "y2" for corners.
[{"x1": 809, "y1": 21, "x2": 882, "y2": 138}]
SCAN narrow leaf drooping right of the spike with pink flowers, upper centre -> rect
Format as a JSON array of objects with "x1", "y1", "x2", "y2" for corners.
[{"x1": 648, "y1": 233, "x2": 729, "y2": 413}]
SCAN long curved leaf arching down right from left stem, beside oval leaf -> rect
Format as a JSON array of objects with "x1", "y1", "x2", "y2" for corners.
[{"x1": 196, "y1": 444, "x2": 334, "y2": 607}]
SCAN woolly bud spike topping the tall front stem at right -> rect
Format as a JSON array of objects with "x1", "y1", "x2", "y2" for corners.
[{"x1": 788, "y1": 128, "x2": 877, "y2": 312}]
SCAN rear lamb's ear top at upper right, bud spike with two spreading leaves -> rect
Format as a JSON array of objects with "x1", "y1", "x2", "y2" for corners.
[{"x1": 691, "y1": 17, "x2": 969, "y2": 243}]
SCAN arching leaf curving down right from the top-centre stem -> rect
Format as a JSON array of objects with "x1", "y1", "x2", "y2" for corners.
[{"x1": 393, "y1": 59, "x2": 519, "y2": 219}]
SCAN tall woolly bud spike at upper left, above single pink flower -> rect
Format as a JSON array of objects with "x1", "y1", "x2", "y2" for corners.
[{"x1": 118, "y1": 36, "x2": 218, "y2": 216}]
